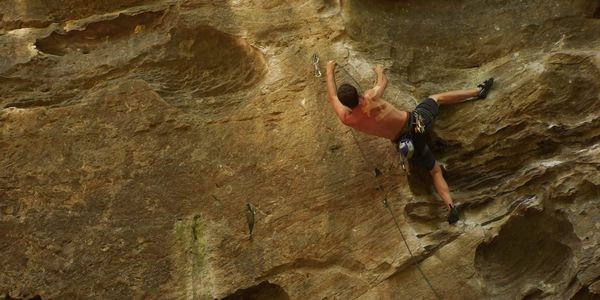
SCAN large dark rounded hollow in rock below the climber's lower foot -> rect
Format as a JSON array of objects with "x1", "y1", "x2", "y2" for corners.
[{"x1": 475, "y1": 209, "x2": 577, "y2": 298}]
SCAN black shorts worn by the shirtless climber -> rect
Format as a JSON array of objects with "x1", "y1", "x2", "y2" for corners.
[{"x1": 406, "y1": 98, "x2": 440, "y2": 171}]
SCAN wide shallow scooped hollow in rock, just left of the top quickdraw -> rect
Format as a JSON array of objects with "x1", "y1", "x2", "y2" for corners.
[{"x1": 135, "y1": 26, "x2": 267, "y2": 114}]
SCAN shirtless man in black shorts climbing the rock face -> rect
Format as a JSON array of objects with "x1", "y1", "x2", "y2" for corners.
[{"x1": 327, "y1": 61, "x2": 494, "y2": 224}]
